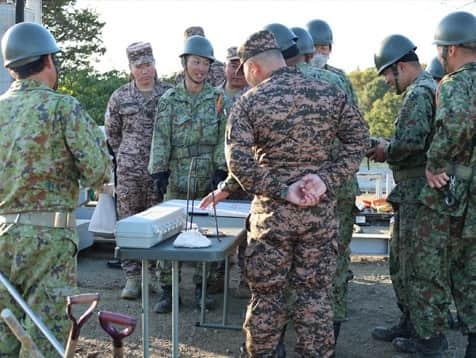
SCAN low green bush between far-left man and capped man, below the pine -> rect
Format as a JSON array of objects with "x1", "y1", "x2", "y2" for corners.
[{"x1": 58, "y1": 69, "x2": 128, "y2": 125}]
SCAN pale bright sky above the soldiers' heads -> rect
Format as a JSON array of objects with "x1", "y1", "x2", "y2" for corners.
[{"x1": 77, "y1": 0, "x2": 476, "y2": 76}]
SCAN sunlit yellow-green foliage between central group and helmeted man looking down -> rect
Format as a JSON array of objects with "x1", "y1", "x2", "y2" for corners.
[{"x1": 349, "y1": 68, "x2": 401, "y2": 138}]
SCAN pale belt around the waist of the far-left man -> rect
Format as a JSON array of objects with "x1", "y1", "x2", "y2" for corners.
[{"x1": 0, "y1": 212, "x2": 76, "y2": 228}]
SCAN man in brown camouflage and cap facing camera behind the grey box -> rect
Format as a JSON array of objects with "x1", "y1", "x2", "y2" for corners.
[{"x1": 105, "y1": 42, "x2": 172, "y2": 299}]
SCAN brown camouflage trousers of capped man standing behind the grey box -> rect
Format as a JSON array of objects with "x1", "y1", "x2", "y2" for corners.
[{"x1": 116, "y1": 172, "x2": 160, "y2": 278}]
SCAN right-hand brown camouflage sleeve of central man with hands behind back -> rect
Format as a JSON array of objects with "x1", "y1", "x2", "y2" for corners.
[{"x1": 318, "y1": 95, "x2": 370, "y2": 192}]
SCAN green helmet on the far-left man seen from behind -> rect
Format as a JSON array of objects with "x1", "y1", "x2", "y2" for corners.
[{"x1": 2, "y1": 22, "x2": 60, "y2": 68}]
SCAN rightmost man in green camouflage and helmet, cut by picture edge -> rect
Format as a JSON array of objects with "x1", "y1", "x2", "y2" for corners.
[{"x1": 404, "y1": 12, "x2": 476, "y2": 358}]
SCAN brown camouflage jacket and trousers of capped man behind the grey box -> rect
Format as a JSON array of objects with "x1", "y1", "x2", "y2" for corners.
[{"x1": 104, "y1": 80, "x2": 172, "y2": 278}]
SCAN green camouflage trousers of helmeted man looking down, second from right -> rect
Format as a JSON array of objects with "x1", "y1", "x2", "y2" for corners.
[{"x1": 389, "y1": 202, "x2": 422, "y2": 314}]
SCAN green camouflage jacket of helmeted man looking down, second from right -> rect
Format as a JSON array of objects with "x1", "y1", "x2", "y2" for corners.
[{"x1": 386, "y1": 71, "x2": 436, "y2": 203}]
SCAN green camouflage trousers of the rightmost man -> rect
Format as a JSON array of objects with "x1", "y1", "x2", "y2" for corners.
[{"x1": 410, "y1": 206, "x2": 476, "y2": 337}]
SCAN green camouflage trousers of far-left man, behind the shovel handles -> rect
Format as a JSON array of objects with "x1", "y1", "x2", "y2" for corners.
[{"x1": 0, "y1": 225, "x2": 78, "y2": 358}]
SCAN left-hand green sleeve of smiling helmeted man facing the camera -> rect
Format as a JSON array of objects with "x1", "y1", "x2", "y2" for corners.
[{"x1": 148, "y1": 97, "x2": 173, "y2": 174}]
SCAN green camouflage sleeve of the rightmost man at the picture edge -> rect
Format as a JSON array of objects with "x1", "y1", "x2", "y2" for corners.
[{"x1": 427, "y1": 79, "x2": 475, "y2": 173}]
